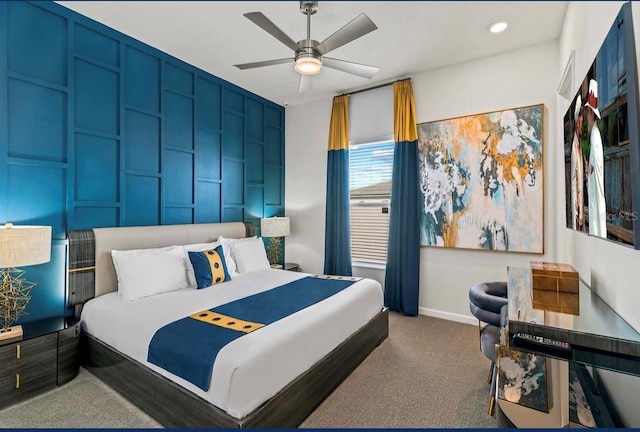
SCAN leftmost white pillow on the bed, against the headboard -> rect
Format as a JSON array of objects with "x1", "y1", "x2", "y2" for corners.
[{"x1": 111, "y1": 246, "x2": 189, "y2": 300}]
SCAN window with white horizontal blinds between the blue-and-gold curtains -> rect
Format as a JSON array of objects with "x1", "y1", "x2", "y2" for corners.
[{"x1": 349, "y1": 141, "x2": 394, "y2": 264}]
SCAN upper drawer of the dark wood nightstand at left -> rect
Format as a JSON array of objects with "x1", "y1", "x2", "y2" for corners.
[{"x1": 0, "y1": 333, "x2": 58, "y2": 376}]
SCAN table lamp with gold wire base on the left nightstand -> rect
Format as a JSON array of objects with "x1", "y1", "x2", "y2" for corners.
[{"x1": 0, "y1": 223, "x2": 51, "y2": 340}]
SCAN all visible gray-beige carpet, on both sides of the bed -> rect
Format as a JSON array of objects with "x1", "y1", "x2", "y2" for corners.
[{"x1": 0, "y1": 313, "x2": 497, "y2": 428}]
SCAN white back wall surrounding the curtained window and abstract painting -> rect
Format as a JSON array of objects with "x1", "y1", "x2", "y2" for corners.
[{"x1": 285, "y1": 42, "x2": 558, "y2": 323}]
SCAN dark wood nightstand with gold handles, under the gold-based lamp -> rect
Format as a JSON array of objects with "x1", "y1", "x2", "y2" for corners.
[{"x1": 0, "y1": 317, "x2": 80, "y2": 408}]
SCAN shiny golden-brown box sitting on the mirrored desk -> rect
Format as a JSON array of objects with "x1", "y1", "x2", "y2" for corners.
[{"x1": 530, "y1": 261, "x2": 580, "y2": 315}]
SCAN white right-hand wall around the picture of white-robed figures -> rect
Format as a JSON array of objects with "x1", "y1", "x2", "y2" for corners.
[{"x1": 556, "y1": 2, "x2": 640, "y2": 427}]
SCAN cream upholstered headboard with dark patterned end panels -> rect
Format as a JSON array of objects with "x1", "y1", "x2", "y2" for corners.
[{"x1": 68, "y1": 222, "x2": 255, "y2": 314}]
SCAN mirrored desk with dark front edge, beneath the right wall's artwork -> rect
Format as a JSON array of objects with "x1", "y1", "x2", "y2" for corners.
[{"x1": 497, "y1": 267, "x2": 640, "y2": 427}]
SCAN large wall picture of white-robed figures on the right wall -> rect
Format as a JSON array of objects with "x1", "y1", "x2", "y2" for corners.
[{"x1": 563, "y1": 3, "x2": 640, "y2": 249}]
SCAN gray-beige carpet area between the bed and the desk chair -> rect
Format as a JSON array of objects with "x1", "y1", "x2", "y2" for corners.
[{"x1": 301, "y1": 314, "x2": 498, "y2": 428}]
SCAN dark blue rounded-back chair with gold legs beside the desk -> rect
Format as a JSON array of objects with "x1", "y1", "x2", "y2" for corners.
[{"x1": 469, "y1": 282, "x2": 507, "y2": 415}]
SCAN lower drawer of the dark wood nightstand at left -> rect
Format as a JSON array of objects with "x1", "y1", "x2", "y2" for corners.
[{"x1": 0, "y1": 362, "x2": 56, "y2": 407}]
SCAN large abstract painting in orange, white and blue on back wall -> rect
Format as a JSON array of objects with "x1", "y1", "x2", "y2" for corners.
[{"x1": 418, "y1": 105, "x2": 544, "y2": 254}]
